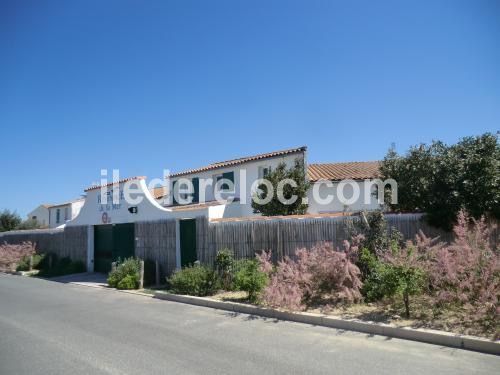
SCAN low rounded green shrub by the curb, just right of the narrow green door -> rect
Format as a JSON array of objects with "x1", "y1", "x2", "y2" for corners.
[{"x1": 167, "y1": 265, "x2": 220, "y2": 297}]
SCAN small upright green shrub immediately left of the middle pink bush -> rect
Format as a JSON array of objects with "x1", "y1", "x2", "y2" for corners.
[{"x1": 234, "y1": 259, "x2": 267, "y2": 302}]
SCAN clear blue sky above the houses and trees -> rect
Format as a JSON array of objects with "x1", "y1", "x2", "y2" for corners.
[{"x1": 0, "y1": 0, "x2": 500, "y2": 215}]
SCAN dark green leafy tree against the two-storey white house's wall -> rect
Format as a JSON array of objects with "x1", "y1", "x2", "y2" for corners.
[{"x1": 252, "y1": 159, "x2": 310, "y2": 216}]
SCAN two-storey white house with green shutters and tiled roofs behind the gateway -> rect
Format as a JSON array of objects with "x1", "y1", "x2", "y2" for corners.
[{"x1": 152, "y1": 147, "x2": 381, "y2": 217}]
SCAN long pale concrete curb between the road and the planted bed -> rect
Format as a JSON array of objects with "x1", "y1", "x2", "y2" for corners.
[{"x1": 154, "y1": 292, "x2": 500, "y2": 355}]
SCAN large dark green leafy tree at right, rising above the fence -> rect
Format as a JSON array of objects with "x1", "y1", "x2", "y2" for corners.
[{"x1": 381, "y1": 133, "x2": 500, "y2": 230}]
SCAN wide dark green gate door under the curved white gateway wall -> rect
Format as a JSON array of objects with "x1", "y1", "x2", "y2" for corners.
[{"x1": 94, "y1": 223, "x2": 135, "y2": 273}]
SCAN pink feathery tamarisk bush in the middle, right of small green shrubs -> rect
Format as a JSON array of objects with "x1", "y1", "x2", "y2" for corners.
[{"x1": 257, "y1": 242, "x2": 362, "y2": 310}]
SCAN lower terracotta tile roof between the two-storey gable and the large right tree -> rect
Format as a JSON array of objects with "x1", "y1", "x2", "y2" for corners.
[{"x1": 307, "y1": 161, "x2": 380, "y2": 182}]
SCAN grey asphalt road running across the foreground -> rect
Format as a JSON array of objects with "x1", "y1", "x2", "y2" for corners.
[{"x1": 0, "y1": 274, "x2": 500, "y2": 375}]
